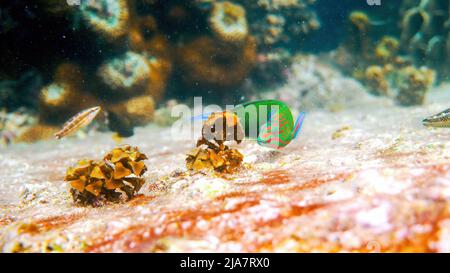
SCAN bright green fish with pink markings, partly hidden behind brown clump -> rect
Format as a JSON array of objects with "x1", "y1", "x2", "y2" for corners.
[{"x1": 194, "y1": 100, "x2": 305, "y2": 149}]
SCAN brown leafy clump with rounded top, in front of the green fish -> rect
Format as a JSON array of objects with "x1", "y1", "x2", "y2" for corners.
[{"x1": 186, "y1": 112, "x2": 244, "y2": 174}]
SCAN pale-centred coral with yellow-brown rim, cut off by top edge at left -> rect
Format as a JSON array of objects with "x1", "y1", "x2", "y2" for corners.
[{"x1": 80, "y1": 0, "x2": 129, "y2": 39}]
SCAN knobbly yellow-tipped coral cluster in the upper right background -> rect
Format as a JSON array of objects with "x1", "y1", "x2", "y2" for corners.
[{"x1": 335, "y1": 11, "x2": 436, "y2": 106}]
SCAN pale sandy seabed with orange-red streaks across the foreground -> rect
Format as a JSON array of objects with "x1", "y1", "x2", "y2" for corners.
[{"x1": 0, "y1": 84, "x2": 450, "y2": 252}]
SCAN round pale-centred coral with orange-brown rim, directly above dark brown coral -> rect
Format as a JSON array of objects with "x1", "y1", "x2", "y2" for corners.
[{"x1": 209, "y1": 1, "x2": 249, "y2": 42}]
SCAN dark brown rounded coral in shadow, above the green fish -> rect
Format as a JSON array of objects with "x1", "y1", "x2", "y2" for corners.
[{"x1": 178, "y1": 36, "x2": 256, "y2": 87}]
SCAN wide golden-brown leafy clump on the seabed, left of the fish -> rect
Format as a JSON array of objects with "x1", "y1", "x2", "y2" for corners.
[{"x1": 65, "y1": 145, "x2": 147, "y2": 206}]
